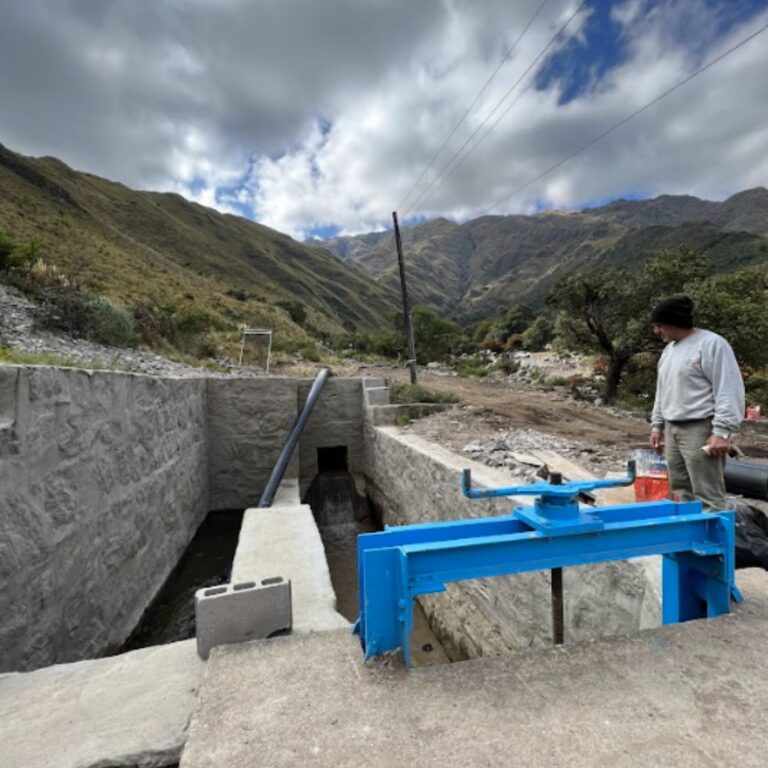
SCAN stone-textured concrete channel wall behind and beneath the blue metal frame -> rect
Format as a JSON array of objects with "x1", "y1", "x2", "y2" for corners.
[{"x1": 365, "y1": 424, "x2": 659, "y2": 659}]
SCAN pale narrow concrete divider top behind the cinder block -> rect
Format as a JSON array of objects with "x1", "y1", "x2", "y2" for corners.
[{"x1": 232, "y1": 504, "x2": 349, "y2": 633}]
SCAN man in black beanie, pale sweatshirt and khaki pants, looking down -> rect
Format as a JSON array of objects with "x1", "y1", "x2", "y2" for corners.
[{"x1": 651, "y1": 296, "x2": 744, "y2": 512}]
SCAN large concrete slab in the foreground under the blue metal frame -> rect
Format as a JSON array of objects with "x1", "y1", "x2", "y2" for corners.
[{"x1": 181, "y1": 572, "x2": 768, "y2": 768}]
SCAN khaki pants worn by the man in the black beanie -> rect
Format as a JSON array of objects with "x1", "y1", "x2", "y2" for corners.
[{"x1": 664, "y1": 419, "x2": 727, "y2": 512}]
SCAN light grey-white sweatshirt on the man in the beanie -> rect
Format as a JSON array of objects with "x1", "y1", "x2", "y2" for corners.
[{"x1": 651, "y1": 328, "x2": 744, "y2": 437}]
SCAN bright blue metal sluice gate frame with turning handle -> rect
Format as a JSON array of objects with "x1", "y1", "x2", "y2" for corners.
[{"x1": 354, "y1": 466, "x2": 738, "y2": 664}]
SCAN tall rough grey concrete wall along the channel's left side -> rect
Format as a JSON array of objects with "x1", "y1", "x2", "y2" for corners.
[{"x1": 0, "y1": 366, "x2": 208, "y2": 671}]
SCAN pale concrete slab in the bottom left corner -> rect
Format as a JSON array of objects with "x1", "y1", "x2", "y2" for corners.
[{"x1": 0, "y1": 640, "x2": 205, "y2": 768}]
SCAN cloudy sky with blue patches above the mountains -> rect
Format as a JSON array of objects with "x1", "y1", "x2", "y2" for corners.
[{"x1": 0, "y1": 0, "x2": 768, "y2": 238}]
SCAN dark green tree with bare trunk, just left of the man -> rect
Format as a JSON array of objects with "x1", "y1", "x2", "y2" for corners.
[{"x1": 547, "y1": 246, "x2": 709, "y2": 403}]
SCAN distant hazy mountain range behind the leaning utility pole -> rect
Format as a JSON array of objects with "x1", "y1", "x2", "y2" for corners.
[{"x1": 312, "y1": 194, "x2": 768, "y2": 322}]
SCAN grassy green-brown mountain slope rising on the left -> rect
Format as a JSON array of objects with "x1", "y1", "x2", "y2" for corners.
[{"x1": 0, "y1": 145, "x2": 397, "y2": 339}]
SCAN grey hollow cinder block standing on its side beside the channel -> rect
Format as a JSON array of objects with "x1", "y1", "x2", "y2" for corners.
[{"x1": 195, "y1": 576, "x2": 293, "y2": 659}]
